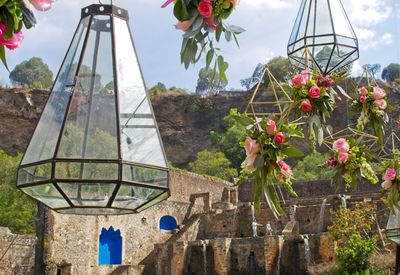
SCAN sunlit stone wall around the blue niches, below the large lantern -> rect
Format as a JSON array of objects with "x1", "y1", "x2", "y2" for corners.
[{"x1": 44, "y1": 172, "x2": 231, "y2": 275}]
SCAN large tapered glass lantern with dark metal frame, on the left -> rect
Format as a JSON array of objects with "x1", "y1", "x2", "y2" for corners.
[{"x1": 17, "y1": 5, "x2": 169, "y2": 215}]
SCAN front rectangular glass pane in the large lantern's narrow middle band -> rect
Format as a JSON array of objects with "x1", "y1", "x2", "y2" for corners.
[{"x1": 56, "y1": 162, "x2": 118, "y2": 180}]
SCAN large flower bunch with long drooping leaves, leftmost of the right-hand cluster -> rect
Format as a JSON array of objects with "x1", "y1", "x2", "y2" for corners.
[{"x1": 233, "y1": 113, "x2": 303, "y2": 217}]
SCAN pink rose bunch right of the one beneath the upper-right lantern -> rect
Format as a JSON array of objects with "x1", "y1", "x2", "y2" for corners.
[{"x1": 351, "y1": 86, "x2": 390, "y2": 143}]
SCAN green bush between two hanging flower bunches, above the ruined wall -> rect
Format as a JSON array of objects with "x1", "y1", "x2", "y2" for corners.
[{"x1": 293, "y1": 151, "x2": 333, "y2": 181}]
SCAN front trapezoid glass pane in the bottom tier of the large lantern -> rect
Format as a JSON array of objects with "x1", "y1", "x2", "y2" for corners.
[{"x1": 58, "y1": 183, "x2": 116, "y2": 207}]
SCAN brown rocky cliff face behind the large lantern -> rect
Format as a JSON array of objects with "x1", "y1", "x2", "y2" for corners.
[{"x1": 0, "y1": 89, "x2": 248, "y2": 167}]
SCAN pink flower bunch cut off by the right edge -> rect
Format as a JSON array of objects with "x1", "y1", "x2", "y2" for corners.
[{"x1": 381, "y1": 149, "x2": 400, "y2": 210}]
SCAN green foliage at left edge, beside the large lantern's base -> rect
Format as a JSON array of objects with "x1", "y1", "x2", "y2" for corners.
[{"x1": 0, "y1": 151, "x2": 37, "y2": 234}]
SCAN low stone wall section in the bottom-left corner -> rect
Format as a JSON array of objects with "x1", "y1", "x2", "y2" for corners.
[{"x1": 0, "y1": 227, "x2": 36, "y2": 275}]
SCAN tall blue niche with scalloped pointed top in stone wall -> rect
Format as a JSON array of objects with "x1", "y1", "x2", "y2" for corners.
[{"x1": 99, "y1": 226, "x2": 122, "y2": 265}]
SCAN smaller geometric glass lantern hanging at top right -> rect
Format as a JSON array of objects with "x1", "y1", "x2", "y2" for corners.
[{"x1": 287, "y1": 0, "x2": 359, "y2": 75}]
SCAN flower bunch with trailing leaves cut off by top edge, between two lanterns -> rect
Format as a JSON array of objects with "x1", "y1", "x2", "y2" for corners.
[{"x1": 161, "y1": 0, "x2": 245, "y2": 83}]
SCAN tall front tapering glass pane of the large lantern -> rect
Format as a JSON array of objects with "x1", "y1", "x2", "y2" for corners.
[{"x1": 58, "y1": 16, "x2": 118, "y2": 159}]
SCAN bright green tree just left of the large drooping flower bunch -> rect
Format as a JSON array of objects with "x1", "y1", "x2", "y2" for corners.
[{"x1": 210, "y1": 109, "x2": 246, "y2": 171}]
